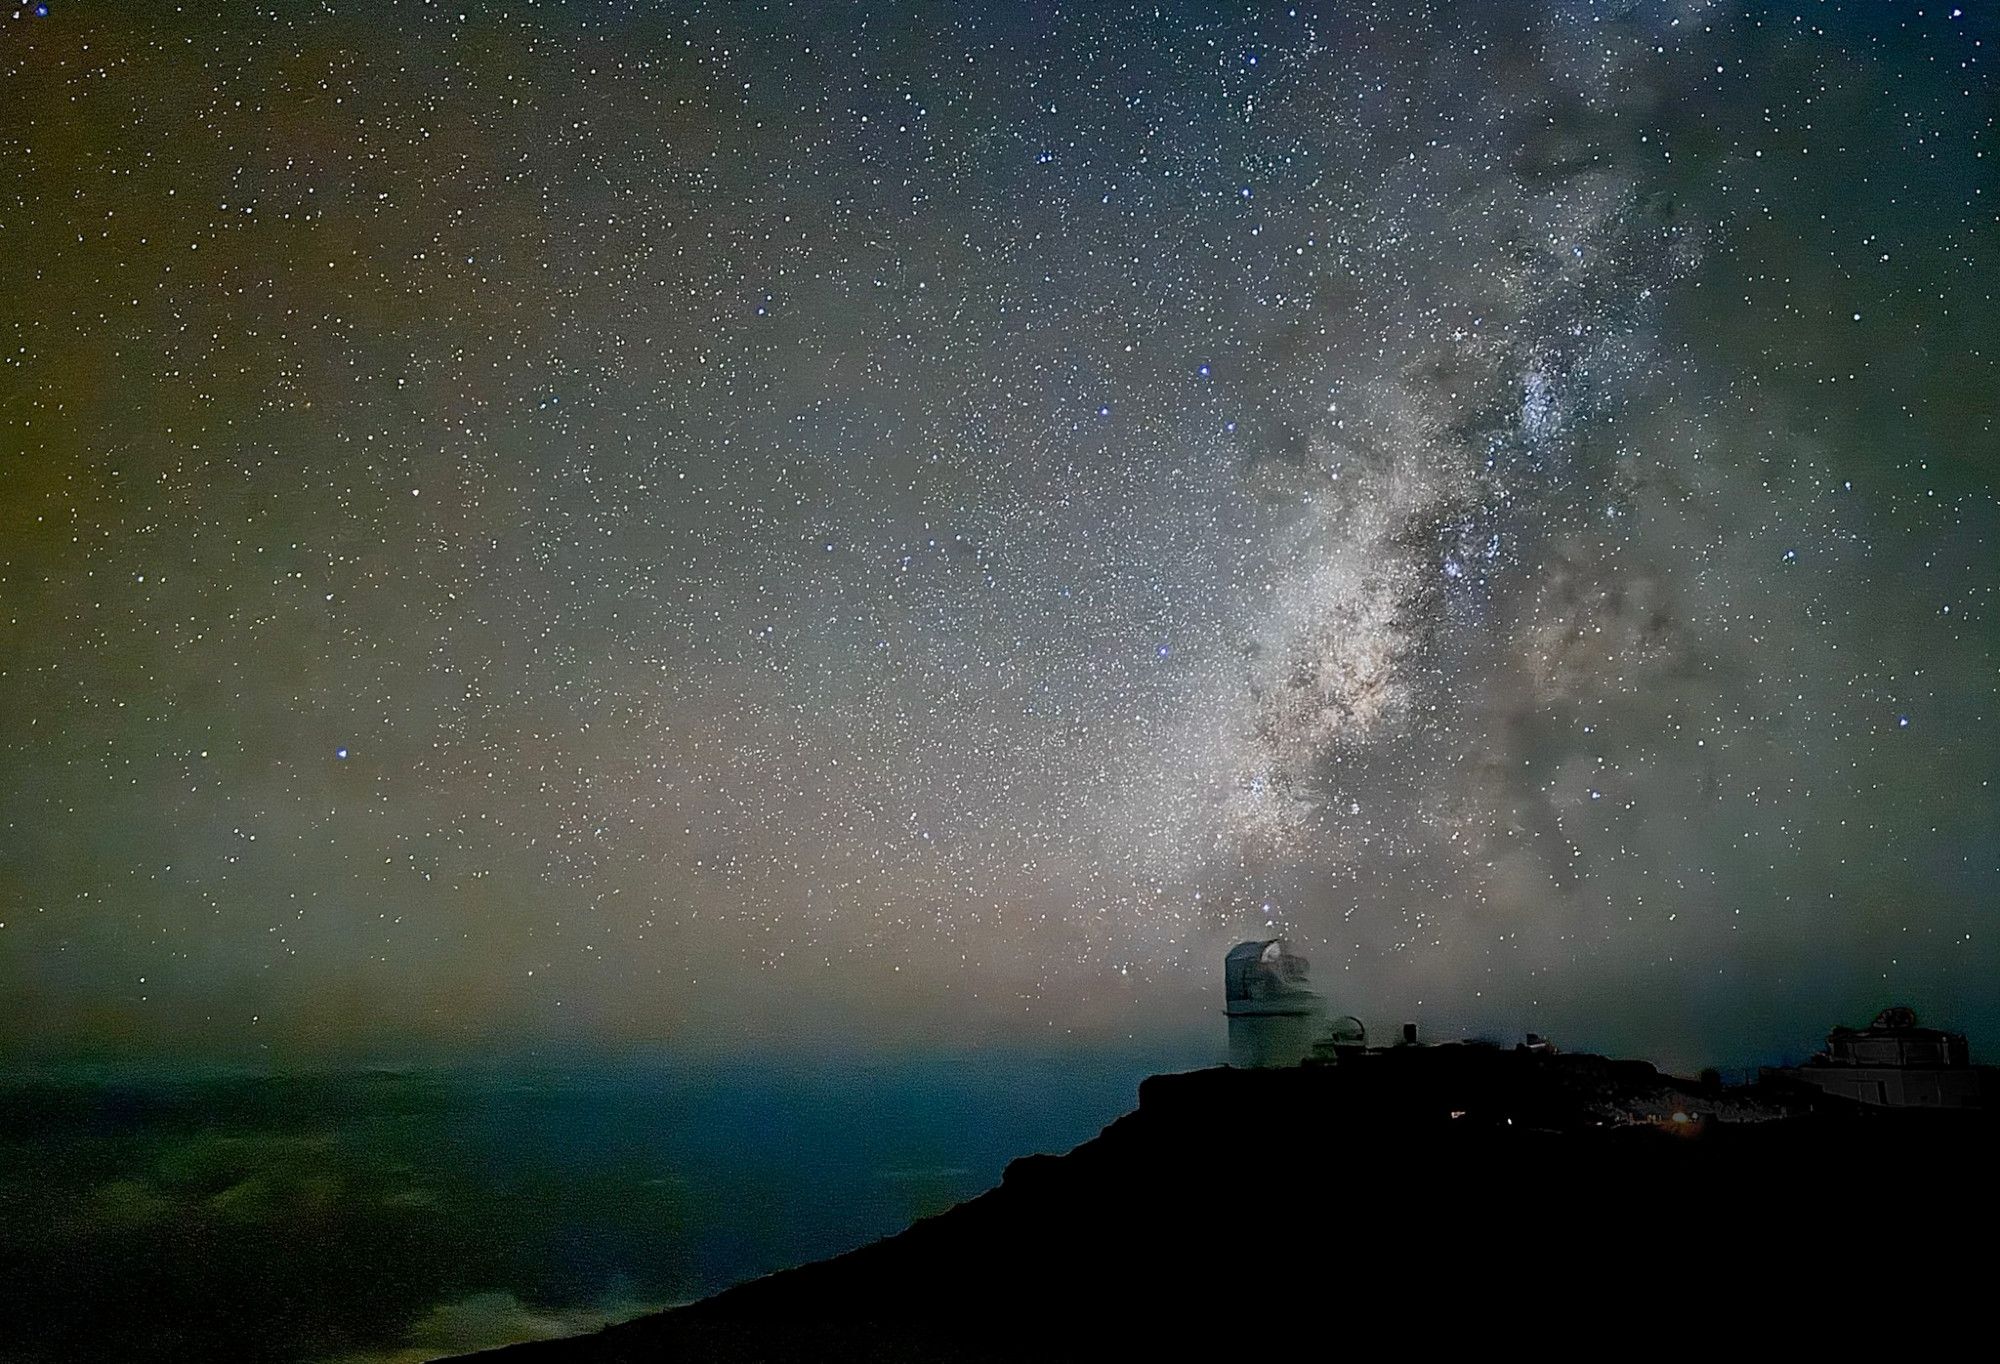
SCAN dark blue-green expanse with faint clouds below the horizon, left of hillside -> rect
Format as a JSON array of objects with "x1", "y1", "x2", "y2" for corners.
[{"x1": 0, "y1": 1052, "x2": 1210, "y2": 1364}]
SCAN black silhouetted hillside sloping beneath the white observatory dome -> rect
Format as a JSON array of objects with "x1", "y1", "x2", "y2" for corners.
[{"x1": 464, "y1": 1046, "x2": 2000, "y2": 1364}]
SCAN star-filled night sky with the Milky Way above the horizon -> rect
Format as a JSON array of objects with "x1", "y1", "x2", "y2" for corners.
[{"x1": 0, "y1": 0, "x2": 2000, "y2": 1064}]
